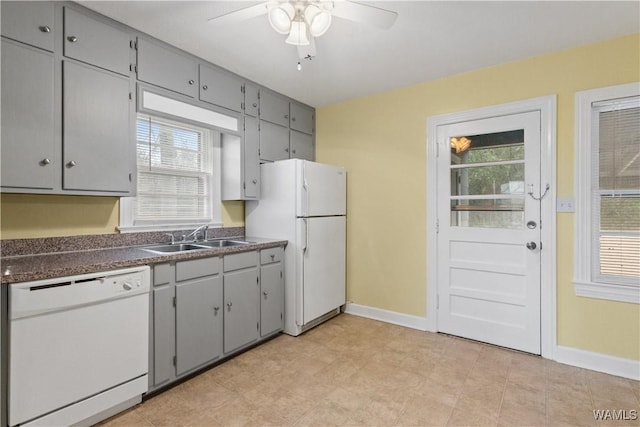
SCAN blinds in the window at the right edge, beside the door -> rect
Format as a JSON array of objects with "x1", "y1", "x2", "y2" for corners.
[{"x1": 592, "y1": 98, "x2": 640, "y2": 278}]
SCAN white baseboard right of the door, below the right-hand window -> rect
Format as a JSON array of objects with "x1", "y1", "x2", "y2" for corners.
[{"x1": 555, "y1": 345, "x2": 640, "y2": 381}]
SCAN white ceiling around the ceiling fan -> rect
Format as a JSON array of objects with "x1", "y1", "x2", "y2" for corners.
[{"x1": 79, "y1": 1, "x2": 640, "y2": 107}]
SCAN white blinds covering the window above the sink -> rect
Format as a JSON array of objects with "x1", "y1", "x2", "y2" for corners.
[{"x1": 134, "y1": 114, "x2": 213, "y2": 224}]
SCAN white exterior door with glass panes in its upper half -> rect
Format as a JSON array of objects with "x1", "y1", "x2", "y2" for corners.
[{"x1": 437, "y1": 111, "x2": 544, "y2": 354}]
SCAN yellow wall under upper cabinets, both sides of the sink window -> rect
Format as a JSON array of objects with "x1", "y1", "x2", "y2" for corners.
[{"x1": 0, "y1": 194, "x2": 244, "y2": 239}]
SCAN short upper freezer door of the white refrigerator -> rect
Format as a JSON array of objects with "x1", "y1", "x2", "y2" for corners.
[{"x1": 297, "y1": 160, "x2": 347, "y2": 217}]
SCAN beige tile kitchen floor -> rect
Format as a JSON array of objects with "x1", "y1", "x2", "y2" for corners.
[{"x1": 105, "y1": 314, "x2": 640, "y2": 427}]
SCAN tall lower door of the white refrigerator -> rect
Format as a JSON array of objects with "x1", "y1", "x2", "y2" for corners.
[{"x1": 299, "y1": 216, "x2": 346, "y2": 324}]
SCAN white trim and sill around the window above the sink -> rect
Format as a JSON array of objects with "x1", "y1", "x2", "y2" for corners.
[{"x1": 118, "y1": 119, "x2": 223, "y2": 233}]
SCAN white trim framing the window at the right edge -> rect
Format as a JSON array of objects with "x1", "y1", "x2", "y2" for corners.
[{"x1": 573, "y1": 83, "x2": 640, "y2": 304}]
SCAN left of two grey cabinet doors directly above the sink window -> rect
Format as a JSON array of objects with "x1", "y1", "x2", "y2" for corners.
[{"x1": 138, "y1": 38, "x2": 198, "y2": 98}]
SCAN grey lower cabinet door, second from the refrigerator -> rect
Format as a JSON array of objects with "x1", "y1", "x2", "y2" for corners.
[{"x1": 224, "y1": 268, "x2": 259, "y2": 354}]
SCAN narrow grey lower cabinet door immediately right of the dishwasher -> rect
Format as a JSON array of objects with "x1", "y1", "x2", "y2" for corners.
[{"x1": 151, "y1": 286, "x2": 176, "y2": 387}]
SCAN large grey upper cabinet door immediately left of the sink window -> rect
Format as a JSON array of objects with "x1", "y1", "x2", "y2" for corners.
[{"x1": 62, "y1": 61, "x2": 135, "y2": 193}]
